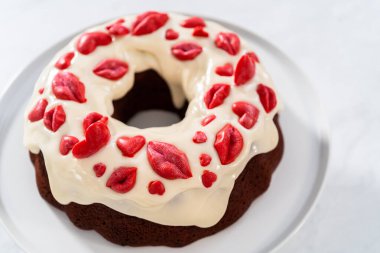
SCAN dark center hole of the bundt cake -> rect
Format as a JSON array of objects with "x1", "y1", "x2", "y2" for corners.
[{"x1": 112, "y1": 70, "x2": 188, "y2": 128}]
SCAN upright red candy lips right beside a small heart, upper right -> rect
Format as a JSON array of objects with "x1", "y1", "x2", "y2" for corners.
[{"x1": 235, "y1": 54, "x2": 256, "y2": 86}]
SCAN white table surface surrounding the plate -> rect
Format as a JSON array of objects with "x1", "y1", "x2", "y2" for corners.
[{"x1": 0, "y1": 0, "x2": 380, "y2": 253}]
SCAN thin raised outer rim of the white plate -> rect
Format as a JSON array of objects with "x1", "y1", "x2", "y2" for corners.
[{"x1": 0, "y1": 13, "x2": 331, "y2": 253}]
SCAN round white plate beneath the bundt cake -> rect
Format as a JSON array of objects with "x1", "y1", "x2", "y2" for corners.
[{"x1": 0, "y1": 16, "x2": 328, "y2": 253}]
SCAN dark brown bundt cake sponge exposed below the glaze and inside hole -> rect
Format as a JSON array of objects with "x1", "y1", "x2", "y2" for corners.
[{"x1": 30, "y1": 71, "x2": 284, "y2": 247}]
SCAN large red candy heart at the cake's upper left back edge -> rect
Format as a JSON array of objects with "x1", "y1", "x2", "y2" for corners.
[{"x1": 76, "y1": 32, "x2": 112, "y2": 55}]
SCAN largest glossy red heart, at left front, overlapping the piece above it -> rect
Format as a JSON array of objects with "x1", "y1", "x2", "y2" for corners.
[{"x1": 72, "y1": 122, "x2": 111, "y2": 159}]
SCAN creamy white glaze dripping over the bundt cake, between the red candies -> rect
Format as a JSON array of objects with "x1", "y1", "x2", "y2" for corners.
[{"x1": 24, "y1": 13, "x2": 281, "y2": 227}]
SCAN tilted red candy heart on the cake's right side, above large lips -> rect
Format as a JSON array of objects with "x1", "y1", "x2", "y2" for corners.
[{"x1": 232, "y1": 101, "x2": 260, "y2": 129}]
